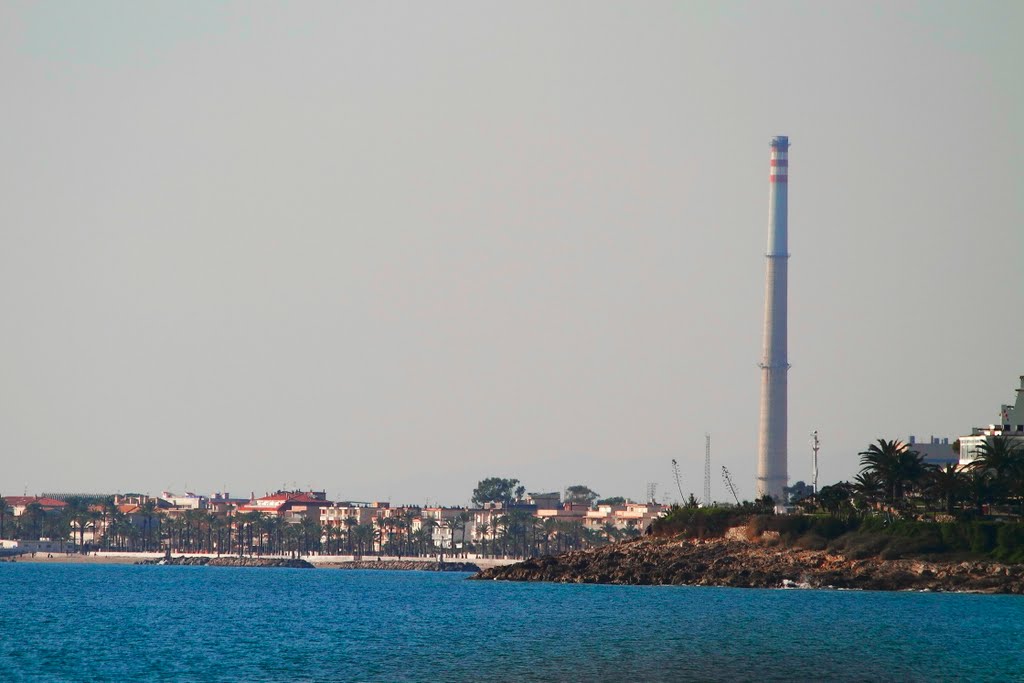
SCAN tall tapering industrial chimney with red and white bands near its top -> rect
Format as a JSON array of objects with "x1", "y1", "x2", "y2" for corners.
[{"x1": 758, "y1": 135, "x2": 790, "y2": 502}]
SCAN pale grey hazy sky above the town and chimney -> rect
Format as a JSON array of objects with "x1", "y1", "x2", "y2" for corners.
[{"x1": 0, "y1": 0, "x2": 1024, "y2": 504}]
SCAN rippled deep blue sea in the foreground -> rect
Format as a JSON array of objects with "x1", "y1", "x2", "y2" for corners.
[{"x1": 0, "y1": 562, "x2": 1024, "y2": 683}]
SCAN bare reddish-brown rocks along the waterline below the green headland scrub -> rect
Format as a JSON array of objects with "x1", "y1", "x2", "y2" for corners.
[{"x1": 473, "y1": 539, "x2": 1024, "y2": 594}]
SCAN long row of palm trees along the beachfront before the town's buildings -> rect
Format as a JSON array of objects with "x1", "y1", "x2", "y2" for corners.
[{"x1": 0, "y1": 499, "x2": 640, "y2": 557}]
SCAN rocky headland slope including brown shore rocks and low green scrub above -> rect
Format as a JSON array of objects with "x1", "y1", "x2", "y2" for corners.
[{"x1": 474, "y1": 509, "x2": 1024, "y2": 594}]
